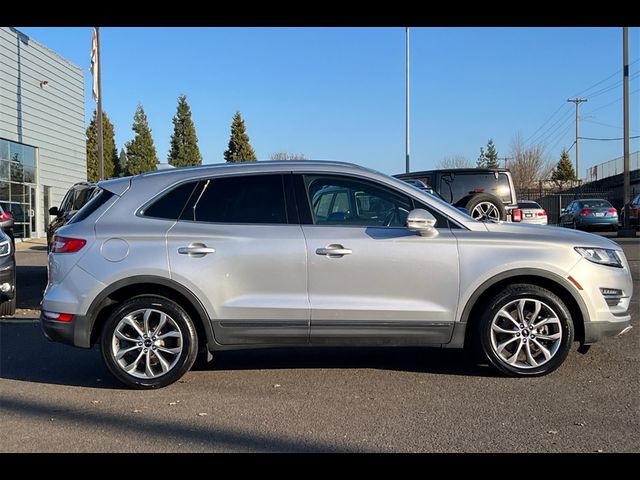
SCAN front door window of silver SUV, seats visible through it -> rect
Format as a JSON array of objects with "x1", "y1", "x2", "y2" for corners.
[{"x1": 305, "y1": 176, "x2": 412, "y2": 227}]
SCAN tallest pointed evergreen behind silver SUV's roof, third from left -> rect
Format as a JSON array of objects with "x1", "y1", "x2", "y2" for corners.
[{"x1": 168, "y1": 95, "x2": 202, "y2": 167}]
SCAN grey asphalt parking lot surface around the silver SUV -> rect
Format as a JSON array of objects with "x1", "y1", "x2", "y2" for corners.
[{"x1": 0, "y1": 234, "x2": 640, "y2": 452}]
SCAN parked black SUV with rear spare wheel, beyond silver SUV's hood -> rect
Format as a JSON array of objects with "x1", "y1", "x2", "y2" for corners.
[{"x1": 395, "y1": 168, "x2": 518, "y2": 220}]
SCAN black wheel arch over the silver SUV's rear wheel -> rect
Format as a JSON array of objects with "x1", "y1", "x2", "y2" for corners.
[{"x1": 88, "y1": 275, "x2": 216, "y2": 349}]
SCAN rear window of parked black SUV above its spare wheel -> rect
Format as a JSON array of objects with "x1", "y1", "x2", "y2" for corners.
[{"x1": 440, "y1": 172, "x2": 511, "y2": 203}]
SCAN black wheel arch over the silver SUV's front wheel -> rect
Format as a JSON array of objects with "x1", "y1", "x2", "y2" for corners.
[{"x1": 460, "y1": 268, "x2": 590, "y2": 348}]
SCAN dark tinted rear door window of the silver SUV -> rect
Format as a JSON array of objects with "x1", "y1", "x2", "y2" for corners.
[{"x1": 180, "y1": 175, "x2": 287, "y2": 223}]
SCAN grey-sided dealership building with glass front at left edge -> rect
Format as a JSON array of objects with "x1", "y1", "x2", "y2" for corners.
[{"x1": 0, "y1": 27, "x2": 87, "y2": 238}]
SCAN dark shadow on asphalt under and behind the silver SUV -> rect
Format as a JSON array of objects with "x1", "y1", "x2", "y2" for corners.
[{"x1": 0, "y1": 322, "x2": 497, "y2": 389}]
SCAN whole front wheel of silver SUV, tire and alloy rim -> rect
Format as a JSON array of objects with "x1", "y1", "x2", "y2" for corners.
[{"x1": 478, "y1": 284, "x2": 574, "y2": 377}]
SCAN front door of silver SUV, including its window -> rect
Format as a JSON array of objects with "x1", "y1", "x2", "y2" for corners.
[{"x1": 298, "y1": 176, "x2": 458, "y2": 344}]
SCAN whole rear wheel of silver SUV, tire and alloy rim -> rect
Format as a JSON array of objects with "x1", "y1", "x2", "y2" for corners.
[{"x1": 100, "y1": 295, "x2": 198, "y2": 389}]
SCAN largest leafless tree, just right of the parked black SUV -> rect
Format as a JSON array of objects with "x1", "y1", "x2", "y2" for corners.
[{"x1": 509, "y1": 133, "x2": 554, "y2": 190}]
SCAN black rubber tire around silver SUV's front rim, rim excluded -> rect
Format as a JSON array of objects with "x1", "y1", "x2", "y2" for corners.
[{"x1": 479, "y1": 285, "x2": 575, "y2": 377}]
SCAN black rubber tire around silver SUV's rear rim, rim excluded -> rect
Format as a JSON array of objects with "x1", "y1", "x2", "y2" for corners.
[{"x1": 100, "y1": 295, "x2": 198, "y2": 389}]
